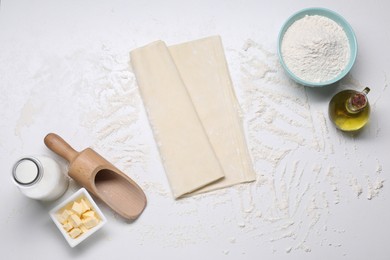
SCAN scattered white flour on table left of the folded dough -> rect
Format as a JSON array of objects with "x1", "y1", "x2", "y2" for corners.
[{"x1": 73, "y1": 46, "x2": 148, "y2": 176}]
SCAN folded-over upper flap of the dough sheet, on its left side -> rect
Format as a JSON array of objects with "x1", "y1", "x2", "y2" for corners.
[{"x1": 130, "y1": 41, "x2": 224, "y2": 198}]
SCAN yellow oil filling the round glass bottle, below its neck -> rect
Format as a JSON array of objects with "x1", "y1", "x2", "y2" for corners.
[{"x1": 329, "y1": 90, "x2": 370, "y2": 131}]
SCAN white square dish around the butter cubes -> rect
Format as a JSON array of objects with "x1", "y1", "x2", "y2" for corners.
[{"x1": 49, "y1": 188, "x2": 107, "y2": 247}]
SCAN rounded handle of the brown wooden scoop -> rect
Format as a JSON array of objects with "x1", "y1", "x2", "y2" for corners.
[{"x1": 44, "y1": 133, "x2": 79, "y2": 163}]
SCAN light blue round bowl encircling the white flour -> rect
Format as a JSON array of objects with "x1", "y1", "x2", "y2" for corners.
[{"x1": 278, "y1": 8, "x2": 357, "y2": 87}]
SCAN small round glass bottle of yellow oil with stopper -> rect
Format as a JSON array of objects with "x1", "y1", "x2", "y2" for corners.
[{"x1": 329, "y1": 87, "x2": 370, "y2": 131}]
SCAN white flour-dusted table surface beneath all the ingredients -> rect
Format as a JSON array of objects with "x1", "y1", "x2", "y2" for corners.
[{"x1": 0, "y1": 0, "x2": 390, "y2": 259}]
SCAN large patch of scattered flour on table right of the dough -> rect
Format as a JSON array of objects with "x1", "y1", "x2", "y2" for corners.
[{"x1": 227, "y1": 40, "x2": 384, "y2": 253}]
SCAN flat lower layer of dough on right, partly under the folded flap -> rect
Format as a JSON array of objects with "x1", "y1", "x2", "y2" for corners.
[{"x1": 168, "y1": 36, "x2": 256, "y2": 192}]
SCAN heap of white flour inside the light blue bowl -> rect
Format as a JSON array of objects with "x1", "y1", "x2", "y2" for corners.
[{"x1": 281, "y1": 15, "x2": 351, "y2": 83}]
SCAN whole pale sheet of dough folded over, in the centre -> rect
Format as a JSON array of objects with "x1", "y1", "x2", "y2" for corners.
[{"x1": 130, "y1": 36, "x2": 256, "y2": 198}]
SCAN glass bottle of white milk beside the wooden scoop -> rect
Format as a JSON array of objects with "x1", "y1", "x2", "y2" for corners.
[{"x1": 12, "y1": 156, "x2": 69, "y2": 201}]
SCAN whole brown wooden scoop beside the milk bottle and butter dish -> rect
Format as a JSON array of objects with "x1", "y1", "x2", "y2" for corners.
[{"x1": 44, "y1": 133, "x2": 146, "y2": 220}]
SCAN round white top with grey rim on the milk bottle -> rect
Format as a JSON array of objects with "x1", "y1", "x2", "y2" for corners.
[{"x1": 12, "y1": 157, "x2": 42, "y2": 186}]
